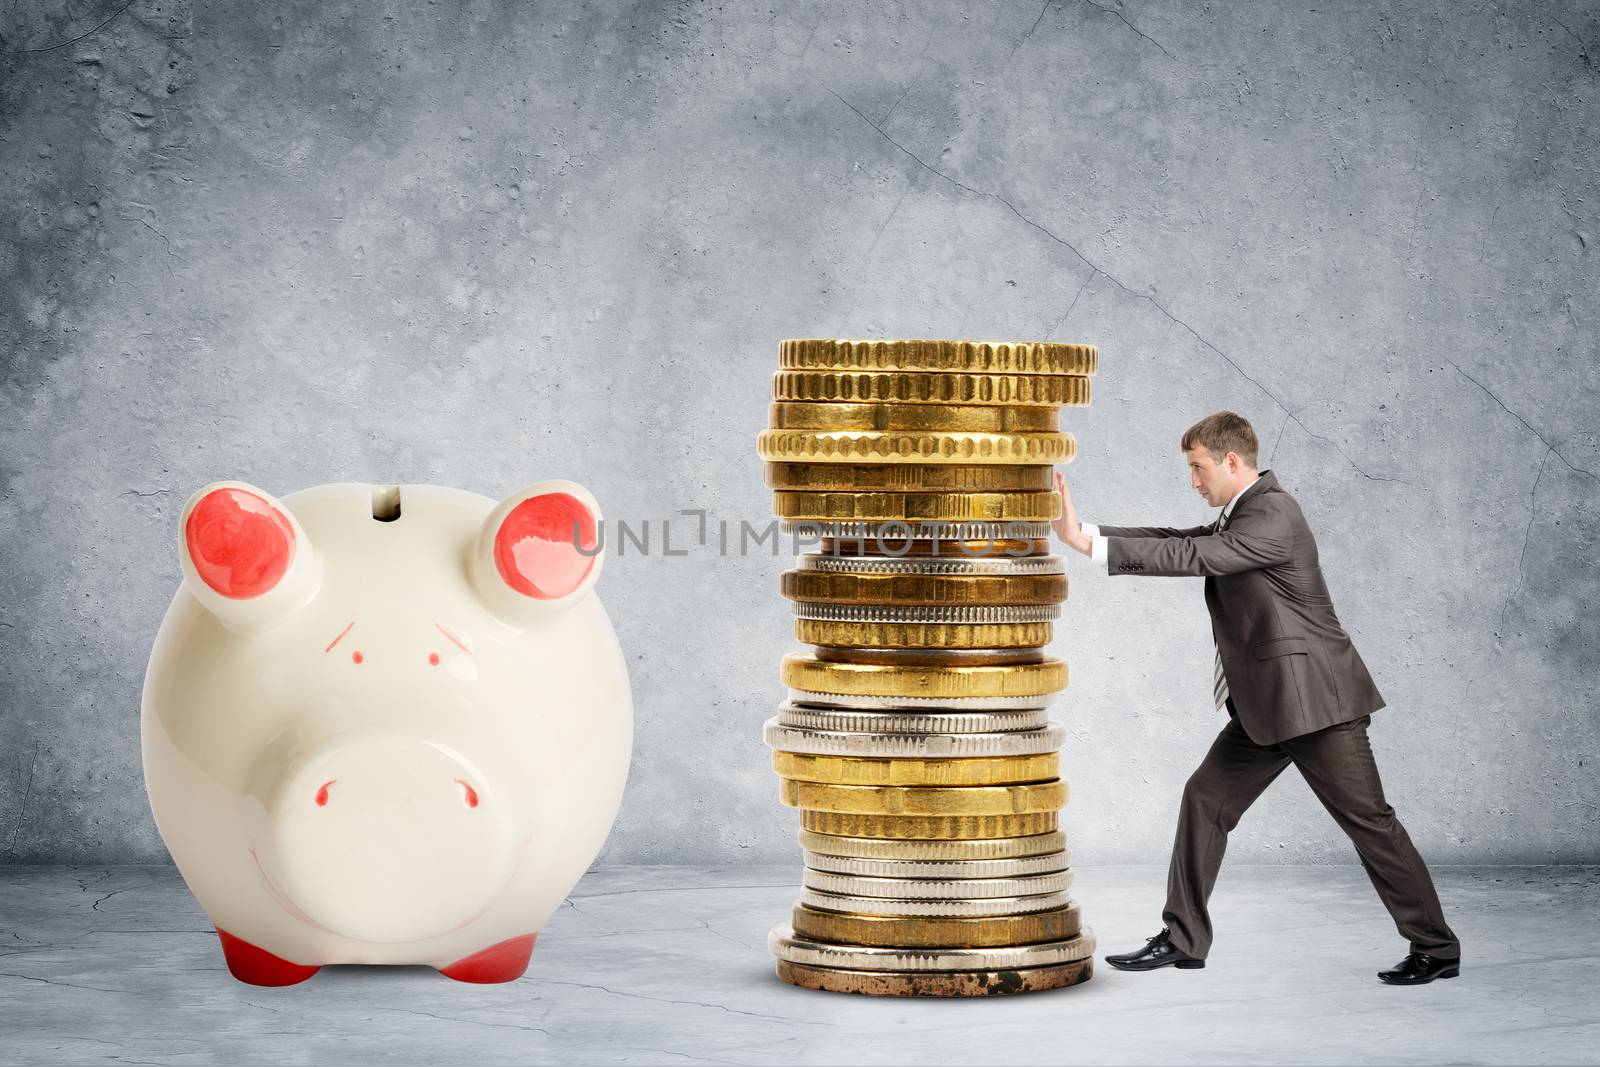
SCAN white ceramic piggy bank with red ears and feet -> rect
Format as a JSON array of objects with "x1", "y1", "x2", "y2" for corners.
[{"x1": 141, "y1": 482, "x2": 634, "y2": 985}]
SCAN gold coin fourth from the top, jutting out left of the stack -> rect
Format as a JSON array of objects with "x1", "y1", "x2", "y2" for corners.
[{"x1": 755, "y1": 430, "x2": 1078, "y2": 464}]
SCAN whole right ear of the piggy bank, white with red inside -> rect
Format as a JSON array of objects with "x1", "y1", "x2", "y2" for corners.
[{"x1": 472, "y1": 478, "x2": 605, "y2": 625}]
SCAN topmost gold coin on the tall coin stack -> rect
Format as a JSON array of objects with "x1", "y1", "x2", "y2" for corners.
[{"x1": 778, "y1": 338, "x2": 1099, "y2": 374}]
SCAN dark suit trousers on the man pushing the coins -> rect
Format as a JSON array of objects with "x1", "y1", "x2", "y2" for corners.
[{"x1": 1162, "y1": 697, "x2": 1461, "y2": 960}]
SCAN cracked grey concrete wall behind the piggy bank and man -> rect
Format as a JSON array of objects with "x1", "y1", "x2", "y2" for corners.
[{"x1": 0, "y1": 0, "x2": 1600, "y2": 862}]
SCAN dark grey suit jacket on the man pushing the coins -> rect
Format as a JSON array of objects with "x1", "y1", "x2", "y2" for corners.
[{"x1": 1099, "y1": 470, "x2": 1384, "y2": 745}]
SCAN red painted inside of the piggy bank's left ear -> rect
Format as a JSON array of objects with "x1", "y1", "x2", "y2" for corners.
[{"x1": 184, "y1": 488, "x2": 294, "y2": 600}]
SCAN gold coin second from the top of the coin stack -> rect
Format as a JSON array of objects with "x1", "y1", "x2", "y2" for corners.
[{"x1": 773, "y1": 371, "x2": 1090, "y2": 408}]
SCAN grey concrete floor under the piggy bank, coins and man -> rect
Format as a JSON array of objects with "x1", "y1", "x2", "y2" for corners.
[{"x1": 0, "y1": 864, "x2": 1600, "y2": 1064}]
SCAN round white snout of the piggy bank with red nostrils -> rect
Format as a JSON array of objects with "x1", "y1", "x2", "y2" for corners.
[{"x1": 256, "y1": 734, "x2": 515, "y2": 942}]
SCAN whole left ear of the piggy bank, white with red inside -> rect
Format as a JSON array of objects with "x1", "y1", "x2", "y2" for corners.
[{"x1": 179, "y1": 482, "x2": 320, "y2": 632}]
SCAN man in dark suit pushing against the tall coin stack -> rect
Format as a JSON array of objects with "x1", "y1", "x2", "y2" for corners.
[{"x1": 1054, "y1": 411, "x2": 1461, "y2": 985}]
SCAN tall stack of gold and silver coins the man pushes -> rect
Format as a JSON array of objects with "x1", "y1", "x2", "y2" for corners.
[{"x1": 757, "y1": 341, "x2": 1099, "y2": 997}]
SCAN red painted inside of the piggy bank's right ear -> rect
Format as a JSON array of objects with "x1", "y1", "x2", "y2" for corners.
[{"x1": 494, "y1": 493, "x2": 598, "y2": 600}]
